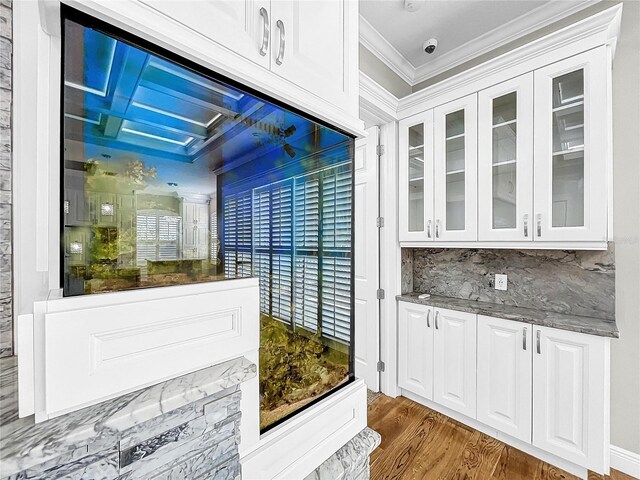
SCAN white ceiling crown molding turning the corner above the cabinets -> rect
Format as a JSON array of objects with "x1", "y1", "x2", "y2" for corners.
[{"x1": 360, "y1": 0, "x2": 601, "y2": 87}]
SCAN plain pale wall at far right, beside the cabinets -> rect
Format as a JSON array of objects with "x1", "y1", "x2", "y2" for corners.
[{"x1": 611, "y1": 0, "x2": 640, "y2": 454}]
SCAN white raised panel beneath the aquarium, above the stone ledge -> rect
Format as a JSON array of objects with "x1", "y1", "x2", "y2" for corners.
[{"x1": 36, "y1": 279, "x2": 259, "y2": 420}]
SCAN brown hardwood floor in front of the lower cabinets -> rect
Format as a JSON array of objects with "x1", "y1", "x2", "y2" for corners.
[{"x1": 369, "y1": 395, "x2": 635, "y2": 480}]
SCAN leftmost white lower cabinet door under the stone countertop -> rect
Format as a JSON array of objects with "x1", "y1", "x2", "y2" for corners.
[{"x1": 398, "y1": 302, "x2": 433, "y2": 400}]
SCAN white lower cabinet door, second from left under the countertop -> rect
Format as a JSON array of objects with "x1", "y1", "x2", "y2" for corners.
[{"x1": 433, "y1": 308, "x2": 476, "y2": 418}]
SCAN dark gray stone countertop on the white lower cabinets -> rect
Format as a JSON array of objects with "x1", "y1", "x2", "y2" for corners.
[{"x1": 396, "y1": 292, "x2": 620, "y2": 338}]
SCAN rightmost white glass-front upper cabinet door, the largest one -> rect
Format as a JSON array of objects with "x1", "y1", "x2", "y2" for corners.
[{"x1": 534, "y1": 47, "x2": 610, "y2": 241}]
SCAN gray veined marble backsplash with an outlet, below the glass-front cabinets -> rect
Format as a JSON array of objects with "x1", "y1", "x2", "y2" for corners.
[{"x1": 402, "y1": 242, "x2": 615, "y2": 318}]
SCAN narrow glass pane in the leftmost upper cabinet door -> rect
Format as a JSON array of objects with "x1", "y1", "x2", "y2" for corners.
[{"x1": 407, "y1": 123, "x2": 424, "y2": 232}]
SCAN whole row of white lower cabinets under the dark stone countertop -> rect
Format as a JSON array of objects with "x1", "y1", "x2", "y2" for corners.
[{"x1": 398, "y1": 302, "x2": 610, "y2": 474}]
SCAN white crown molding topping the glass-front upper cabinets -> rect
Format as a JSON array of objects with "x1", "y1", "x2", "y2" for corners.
[{"x1": 398, "y1": 4, "x2": 622, "y2": 118}]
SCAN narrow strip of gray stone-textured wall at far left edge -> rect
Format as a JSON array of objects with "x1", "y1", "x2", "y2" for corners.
[{"x1": 0, "y1": 0, "x2": 13, "y2": 357}]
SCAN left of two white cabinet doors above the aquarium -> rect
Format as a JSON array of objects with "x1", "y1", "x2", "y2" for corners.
[{"x1": 139, "y1": 0, "x2": 273, "y2": 68}]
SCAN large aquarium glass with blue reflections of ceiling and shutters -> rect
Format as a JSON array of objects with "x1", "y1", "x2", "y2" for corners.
[{"x1": 61, "y1": 19, "x2": 352, "y2": 430}]
